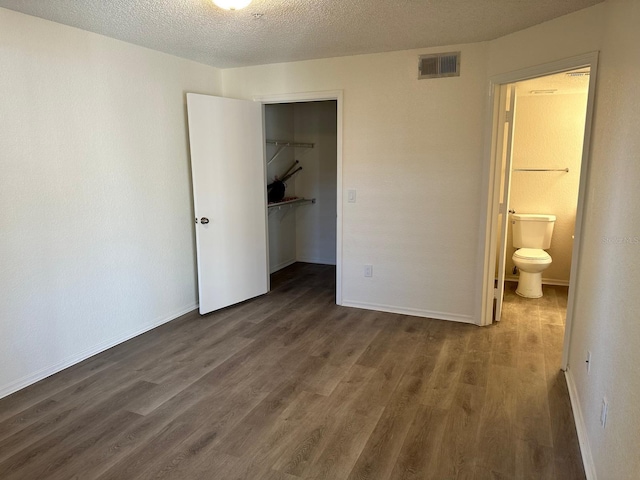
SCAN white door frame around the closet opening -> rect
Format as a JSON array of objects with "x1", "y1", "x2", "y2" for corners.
[{"x1": 253, "y1": 90, "x2": 343, "y2": 305}]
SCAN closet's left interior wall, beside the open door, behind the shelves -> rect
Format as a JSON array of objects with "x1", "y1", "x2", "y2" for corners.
[{"x1": 265, "y1": 103, "x2": 296, "y2": 273}]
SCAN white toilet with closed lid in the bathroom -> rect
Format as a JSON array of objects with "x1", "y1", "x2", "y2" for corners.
[{"x1": 511, "y1": 213, "x2": 556, "y2": 298}]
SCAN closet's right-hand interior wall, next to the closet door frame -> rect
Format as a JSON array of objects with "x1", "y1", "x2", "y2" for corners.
[{"x1": 294, "y1": 101, "x2": 338, "y2": 265}]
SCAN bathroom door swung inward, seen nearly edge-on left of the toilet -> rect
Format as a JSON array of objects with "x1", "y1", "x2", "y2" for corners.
[{"x1": 494, "y1": 85, "x2": 516, "y2": 322}]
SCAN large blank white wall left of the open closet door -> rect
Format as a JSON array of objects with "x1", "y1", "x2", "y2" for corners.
[{"x1": 0, "y1": 9, "x2": 220, "y2": 396}]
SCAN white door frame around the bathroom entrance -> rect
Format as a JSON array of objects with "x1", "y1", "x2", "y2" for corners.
[{"x1": 477, "y1": 51, "x2": 598, "y2": 370}]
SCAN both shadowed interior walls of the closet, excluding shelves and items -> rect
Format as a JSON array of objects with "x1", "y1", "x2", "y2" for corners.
[{"x1": 265, "y1": 101, "x2": 337, "y2": 273}]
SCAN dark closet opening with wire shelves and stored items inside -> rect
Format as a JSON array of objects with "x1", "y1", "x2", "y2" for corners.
[{"x1": 263, "y1": 99, "x2": 340, "y2": 298}]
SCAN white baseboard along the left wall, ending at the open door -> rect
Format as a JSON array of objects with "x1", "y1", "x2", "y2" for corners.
[{"x1": 0, "y1": 303, "x2": 198, "y2": 398}]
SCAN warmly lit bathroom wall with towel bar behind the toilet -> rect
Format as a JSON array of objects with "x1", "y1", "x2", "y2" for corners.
[{"x1": 506, "y1": 92, "x2": 587, "y2": 285}]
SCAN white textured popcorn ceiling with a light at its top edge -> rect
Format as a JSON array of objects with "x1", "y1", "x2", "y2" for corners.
[{"x1": 0, "y1": 0, "x2": 602, "y2": 68}]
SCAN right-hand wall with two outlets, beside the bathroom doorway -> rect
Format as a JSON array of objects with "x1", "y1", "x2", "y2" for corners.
[{"x1": 569, "y1": 0, "x2": 640, "y2": 480}]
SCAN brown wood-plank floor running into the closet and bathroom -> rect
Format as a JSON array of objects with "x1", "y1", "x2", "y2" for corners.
[{"x1": 0, "y1": 264, "x2": 584, "y2": 480}]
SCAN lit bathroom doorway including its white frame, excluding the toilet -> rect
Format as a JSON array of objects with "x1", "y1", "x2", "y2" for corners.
[{"x1": 481, "y1": 54, "x2": 597, "y2": 369}]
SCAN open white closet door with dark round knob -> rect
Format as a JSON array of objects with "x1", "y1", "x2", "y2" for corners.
[{"x1": 187, "y1": 93, "x2": 269, "y2": 314}]
